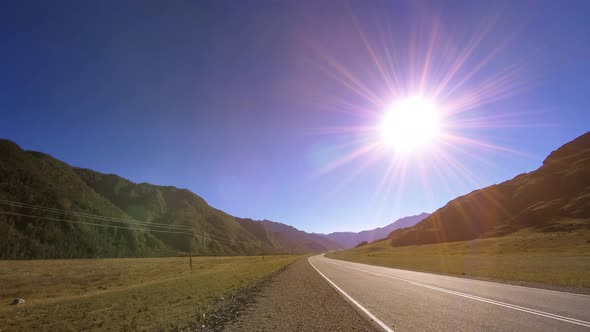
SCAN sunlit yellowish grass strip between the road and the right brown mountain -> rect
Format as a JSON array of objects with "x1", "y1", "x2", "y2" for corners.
[{"x1": 326, "y1": 229, "x2": 590, "y2": 288}]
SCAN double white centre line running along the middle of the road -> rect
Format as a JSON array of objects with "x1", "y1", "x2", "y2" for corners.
[{"x1": 324, "y1": 257, "x2": 590, "y2": 327}]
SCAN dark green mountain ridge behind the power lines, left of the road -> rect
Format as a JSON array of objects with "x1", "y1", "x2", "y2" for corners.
[{"x1": 0, "y1": 140, "x2": 339, "y2": 259}]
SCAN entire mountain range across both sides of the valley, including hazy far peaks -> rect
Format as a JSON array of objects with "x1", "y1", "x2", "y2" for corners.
[{"x1": 6, "y1": 133, "x2": 590, "y2": 259}]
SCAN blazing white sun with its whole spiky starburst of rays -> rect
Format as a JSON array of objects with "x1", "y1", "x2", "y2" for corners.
[{"x1": 310, "y1": 10, "x2": 531, "y2": 210}]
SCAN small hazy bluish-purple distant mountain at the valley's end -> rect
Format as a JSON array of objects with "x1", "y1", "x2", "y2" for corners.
[{"x1": 322, "y1": 213, "x2": 429, "y2": 249}]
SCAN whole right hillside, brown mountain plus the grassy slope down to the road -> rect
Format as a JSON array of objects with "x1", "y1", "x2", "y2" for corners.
[{"x1": 328, "y1": 133, "x2": 590, "y2": 293}]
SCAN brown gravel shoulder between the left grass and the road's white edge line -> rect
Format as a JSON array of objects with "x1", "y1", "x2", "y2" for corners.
[{"x1": 223, "y1": 259, "x2": 376, "y2": 331}]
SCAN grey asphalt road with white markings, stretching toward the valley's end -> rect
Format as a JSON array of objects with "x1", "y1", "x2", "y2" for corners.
[{"x1": 309, "y1": 256, "x2": 590, "y2": 332}]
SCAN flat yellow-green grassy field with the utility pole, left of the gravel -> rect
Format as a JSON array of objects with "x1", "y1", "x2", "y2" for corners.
[{"x1": 0, "y1": 256, "x2": 299, "y2": 331}]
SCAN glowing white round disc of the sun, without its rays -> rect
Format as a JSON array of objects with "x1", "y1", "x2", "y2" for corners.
[{"x1": 379, "y1": 96, "x2": 440, "y2": 153}]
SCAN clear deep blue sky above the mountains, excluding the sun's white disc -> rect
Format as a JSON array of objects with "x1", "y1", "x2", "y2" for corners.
[{"x1": 0, "y1": 0, "x2": 590, "y2": 232}]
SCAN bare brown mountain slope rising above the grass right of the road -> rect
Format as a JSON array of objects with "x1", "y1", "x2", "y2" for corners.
[{"x1": 388, "y1": 132, "x2": 590, "y2": 246}]
